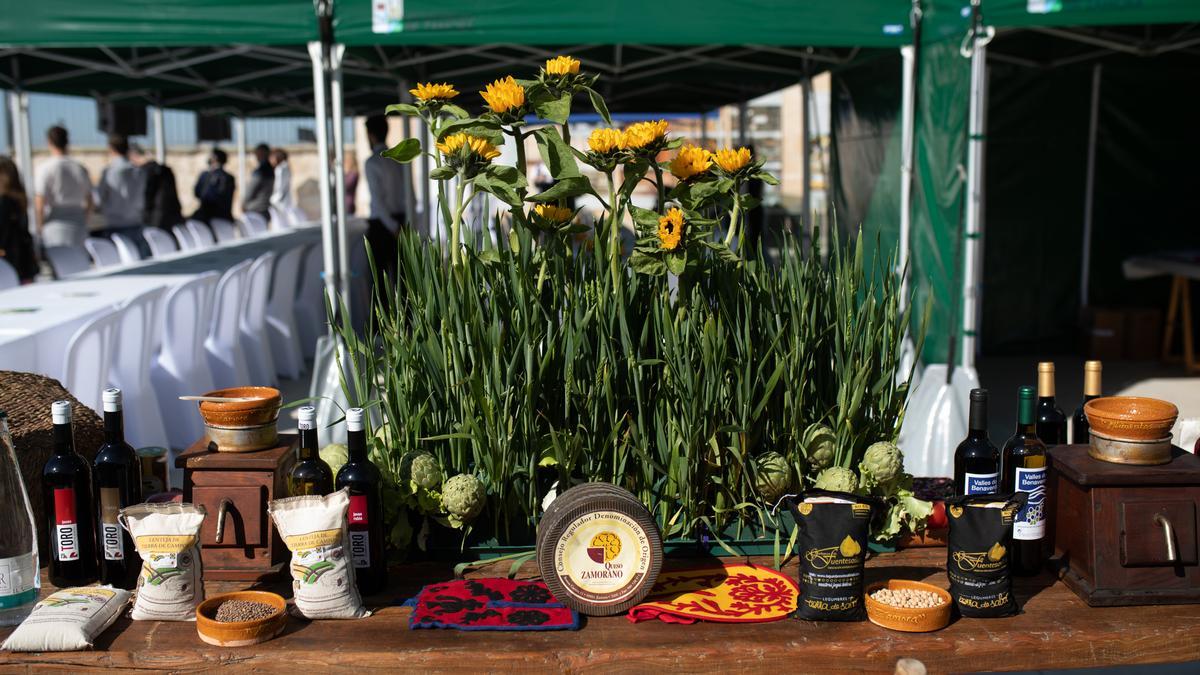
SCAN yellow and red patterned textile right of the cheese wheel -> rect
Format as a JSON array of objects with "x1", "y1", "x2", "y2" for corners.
[{"x1": 628, "y1": 563, "x2": 800, "y2": 623}]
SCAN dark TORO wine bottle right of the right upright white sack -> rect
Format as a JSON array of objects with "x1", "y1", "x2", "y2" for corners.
[{"x1": 337, "y1": 408, "x2": 388, "y2": 596}]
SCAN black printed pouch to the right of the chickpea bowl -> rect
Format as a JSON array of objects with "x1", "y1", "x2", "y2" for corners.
[{"x1": 946, "y1": 492, "x2": 1027, "y2": 619}]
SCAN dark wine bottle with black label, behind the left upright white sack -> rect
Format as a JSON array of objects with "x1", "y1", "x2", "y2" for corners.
[{"x1": 91, "y1": 389, "x2": 142, "y2": 589}]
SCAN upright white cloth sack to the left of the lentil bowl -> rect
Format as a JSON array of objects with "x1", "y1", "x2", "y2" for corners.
[{"x1": 118, "y1": 502, "x2": 205, "y2": 621}]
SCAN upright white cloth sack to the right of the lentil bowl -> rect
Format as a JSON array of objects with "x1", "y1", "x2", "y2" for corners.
[{"x1": 269, "y1": 488, "x2": 371, "y2": 619}]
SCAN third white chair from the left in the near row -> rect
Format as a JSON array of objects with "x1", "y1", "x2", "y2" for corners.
[{"x1": 150, "y1": 271, "x2": 221, "y2": 486}]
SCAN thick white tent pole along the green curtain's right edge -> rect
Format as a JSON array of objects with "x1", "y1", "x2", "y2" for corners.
[{"x1": 961, "y1": 37, "x2": 988, "y2": 369}]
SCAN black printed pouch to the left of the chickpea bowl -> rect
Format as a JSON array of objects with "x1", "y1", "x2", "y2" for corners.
[{"x1": 788, "y1": 490, "x2": 874, "y2": 621}]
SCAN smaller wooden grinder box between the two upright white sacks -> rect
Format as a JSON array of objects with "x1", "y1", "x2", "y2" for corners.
[{"x1": 175, "y1": 434, "x2": 299, "y2": 581}]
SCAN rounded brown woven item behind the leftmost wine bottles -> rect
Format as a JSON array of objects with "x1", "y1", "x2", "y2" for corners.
[{"x1": 0, "y1": 370, "x2": 104, "y2": 565}]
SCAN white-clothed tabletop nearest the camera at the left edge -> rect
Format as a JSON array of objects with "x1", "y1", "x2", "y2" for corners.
[{"x1": 0, "y1": 274, "x2": 194, "y2": 380}]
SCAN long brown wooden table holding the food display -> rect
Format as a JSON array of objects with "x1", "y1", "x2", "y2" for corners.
[{"x1": 0, "y1": 549, "x2": 1200, "y2": 674}]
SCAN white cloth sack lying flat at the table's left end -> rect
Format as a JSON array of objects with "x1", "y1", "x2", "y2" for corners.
[{"x1": 0, "y1": 586, "x2": 130, "y2": 651}]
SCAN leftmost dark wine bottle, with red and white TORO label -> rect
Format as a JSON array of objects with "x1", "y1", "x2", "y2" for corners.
[{"x1": 42, "y1": 401, "x2": 96, "y2": 589}]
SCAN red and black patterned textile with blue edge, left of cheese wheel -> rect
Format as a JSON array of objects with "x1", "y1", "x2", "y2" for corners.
[{"x1": 404, "y1": 579, "x2": 580, "y2": 631}]
